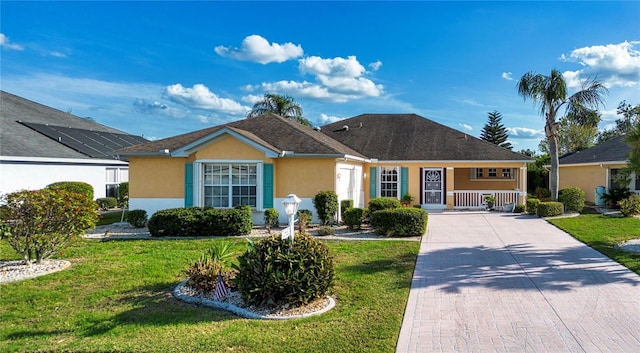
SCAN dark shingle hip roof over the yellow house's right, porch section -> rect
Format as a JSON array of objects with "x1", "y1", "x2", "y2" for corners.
[{"x1": 321, "y1": 114, "x2": 531, "y2": 161}]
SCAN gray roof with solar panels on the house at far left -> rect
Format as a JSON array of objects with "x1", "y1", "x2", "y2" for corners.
[{"x1": 0, "y1": 91, "x2": 147, "y2": 159}]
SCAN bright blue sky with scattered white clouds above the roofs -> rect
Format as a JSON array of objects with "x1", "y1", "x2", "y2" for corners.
[{"x1": 0, "y1": 0, "x2": 640, "y2": 150}]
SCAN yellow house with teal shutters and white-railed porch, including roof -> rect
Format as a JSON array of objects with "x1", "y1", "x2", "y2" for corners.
[{"x1": 117, "y1": 114, "x2": 533, "y2": 223}]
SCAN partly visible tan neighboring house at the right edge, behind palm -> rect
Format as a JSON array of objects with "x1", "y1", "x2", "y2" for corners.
[{"x1": 558, "y1": 136, "x2": 640, "y2": 203}]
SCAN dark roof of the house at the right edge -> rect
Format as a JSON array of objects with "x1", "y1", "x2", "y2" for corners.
[{"x1": 559, "y1": 136, "x2": 631, "y2": 165}]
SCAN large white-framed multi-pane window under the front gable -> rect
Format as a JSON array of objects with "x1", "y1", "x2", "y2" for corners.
[{"x1": 201, "y1": 163, "x2": 259, "y2": 208}]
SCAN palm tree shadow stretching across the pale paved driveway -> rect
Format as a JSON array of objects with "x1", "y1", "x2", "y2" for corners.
[{"x1": 414, "y1": 244, "x2": 640, "y2": 293}]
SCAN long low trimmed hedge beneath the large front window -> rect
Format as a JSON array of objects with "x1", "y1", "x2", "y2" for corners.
[{"x1": 147, "y1": 206, "x2": 253, "y2": 237}]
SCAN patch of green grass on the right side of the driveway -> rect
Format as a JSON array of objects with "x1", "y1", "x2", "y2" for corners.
[{"x1": 549, "y1": 214, "x2": 640, "y2": 274}]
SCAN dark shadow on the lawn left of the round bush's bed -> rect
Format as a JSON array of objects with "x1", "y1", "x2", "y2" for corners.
[{"x1": 82, "y1": 283, "x2": 238, "y2": 337}]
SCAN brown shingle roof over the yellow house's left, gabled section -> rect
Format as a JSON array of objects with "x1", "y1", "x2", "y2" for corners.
[{"x1": 118, "y1": 114, "x2": 364, "y2": 157}]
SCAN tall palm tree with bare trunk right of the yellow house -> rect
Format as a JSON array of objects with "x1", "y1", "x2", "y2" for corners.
[{"x1": 517, "y1": 69, "x2": 608, "y2": 201}]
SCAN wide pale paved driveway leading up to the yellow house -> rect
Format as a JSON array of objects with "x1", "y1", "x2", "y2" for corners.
[{"x1": 396, "y1": 212, "x2": 640, "y2": 353}]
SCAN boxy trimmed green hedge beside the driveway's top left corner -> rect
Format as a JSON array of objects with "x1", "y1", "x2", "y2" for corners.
[{"x1": 370, "y1": 208, "x2": 429, "y2": 237}]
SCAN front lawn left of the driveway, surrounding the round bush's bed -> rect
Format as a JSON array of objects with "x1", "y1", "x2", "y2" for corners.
[{"x1": 0, "y1": 234, "x2": 420, "y2": 353}]
